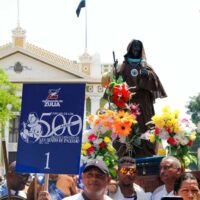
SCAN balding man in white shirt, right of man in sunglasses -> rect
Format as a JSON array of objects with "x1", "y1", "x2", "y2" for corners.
[{"x1": 151, "y1": 156, "x2": 182, "y2": 200}]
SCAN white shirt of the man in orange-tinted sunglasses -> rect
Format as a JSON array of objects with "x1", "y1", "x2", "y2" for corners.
[{"x1": 109, "y1": 183, "x2": 148, "y2": 200}]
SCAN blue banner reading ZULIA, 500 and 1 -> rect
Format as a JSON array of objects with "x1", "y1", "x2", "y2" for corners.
[{"x1": 16, "y1": 83, "x2": 85, "y2": 174}]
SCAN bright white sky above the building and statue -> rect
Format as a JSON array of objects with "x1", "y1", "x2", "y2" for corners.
[{"x1": 0, "y1": 0, "x2": 200, "y2": 115}]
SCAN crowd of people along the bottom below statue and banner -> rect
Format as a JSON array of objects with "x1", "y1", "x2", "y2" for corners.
[{"x1": 0, "y1": 156, "x2": 200, "y2": 200}]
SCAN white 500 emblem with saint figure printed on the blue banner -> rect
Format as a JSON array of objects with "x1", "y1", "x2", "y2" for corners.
[{"x1": 20, "y1": 112, "x2": 82, "y2": 144}]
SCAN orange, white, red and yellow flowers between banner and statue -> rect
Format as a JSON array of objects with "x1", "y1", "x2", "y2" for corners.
[{"x1": 82, "y1": 110, "x2": 137, "y2": 178}]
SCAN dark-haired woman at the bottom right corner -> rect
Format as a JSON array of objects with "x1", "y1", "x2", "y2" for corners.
[{"x1": 174, "y1": 173, "x2": 200, "y2": 200}]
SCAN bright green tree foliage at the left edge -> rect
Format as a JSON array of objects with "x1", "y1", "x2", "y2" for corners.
[{"x1": 0, "y1": 69, "x2": 20, "y2": 139}]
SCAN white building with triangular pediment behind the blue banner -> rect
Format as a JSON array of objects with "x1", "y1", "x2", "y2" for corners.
[{"x1": 0, "y1": 25, "x2": 111, "y2": 163}]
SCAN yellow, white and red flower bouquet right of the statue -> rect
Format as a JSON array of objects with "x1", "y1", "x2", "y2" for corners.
[{"x1": 149, "y1": 106, "x2": 197, "y2": 167}]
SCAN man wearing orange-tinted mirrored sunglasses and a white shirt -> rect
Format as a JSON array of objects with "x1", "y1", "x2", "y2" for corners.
[{"x1": 109, "y1": 157, "x2": 148, "y2": 200}]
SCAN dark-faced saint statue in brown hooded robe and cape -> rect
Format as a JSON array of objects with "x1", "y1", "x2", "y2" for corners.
[{"x1": 104, "y1": 40, "x2": 167, "y2": 157}]
